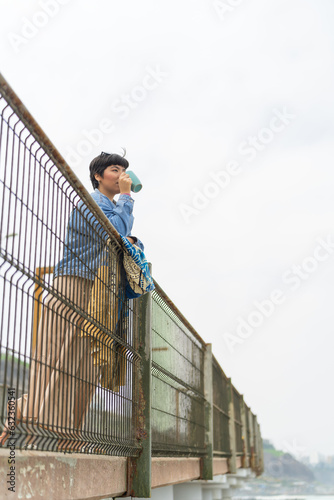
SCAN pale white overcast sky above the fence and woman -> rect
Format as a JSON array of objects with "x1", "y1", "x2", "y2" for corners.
[{"x1": 0, "y1": 0, "x2": 334, "y2": 455}]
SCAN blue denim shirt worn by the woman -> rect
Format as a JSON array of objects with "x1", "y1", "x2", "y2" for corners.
[{"x1": 54, "y1": 189, "x2": 144, "y2": 280}]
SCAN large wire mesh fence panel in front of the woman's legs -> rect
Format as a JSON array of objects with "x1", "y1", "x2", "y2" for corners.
[{"x1": 0, "y1": 90, "x2": 139, "y2": 455}]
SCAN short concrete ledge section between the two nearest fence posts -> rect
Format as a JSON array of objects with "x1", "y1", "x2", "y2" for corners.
[{"x1": 152, "y1": 457, "x2": 201, "y2": 488}]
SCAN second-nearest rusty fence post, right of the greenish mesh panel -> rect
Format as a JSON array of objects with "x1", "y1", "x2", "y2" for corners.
[{"x1": 201, "y1": 344, "x2": 213, "y2": 479}]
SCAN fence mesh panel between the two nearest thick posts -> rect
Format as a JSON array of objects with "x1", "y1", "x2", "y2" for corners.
[{"x1": 152, "y1": 291, "x2": 205, "y2": 455}]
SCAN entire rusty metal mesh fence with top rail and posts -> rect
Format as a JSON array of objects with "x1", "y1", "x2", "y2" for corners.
[{"x1": 0, "y1": 76, "x2": 263, "y2": 496}]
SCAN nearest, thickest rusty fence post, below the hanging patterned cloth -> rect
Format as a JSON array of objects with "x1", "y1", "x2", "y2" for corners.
[{"x1": 128, "y1": 264, "x2": 152, "y2": 498}]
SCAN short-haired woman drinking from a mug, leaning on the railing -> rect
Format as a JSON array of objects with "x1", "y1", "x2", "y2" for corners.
[{"x1": 0, "y1": 153, "x2": 143, "y2": 450}]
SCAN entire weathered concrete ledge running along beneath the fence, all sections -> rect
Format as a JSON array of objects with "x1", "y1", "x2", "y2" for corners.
[{"x1": 0, "y1": 448, "x2": 245, "y2": 500}]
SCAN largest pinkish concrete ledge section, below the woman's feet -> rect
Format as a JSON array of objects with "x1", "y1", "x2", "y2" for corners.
[{"x1": 0, "y1": 448, "x2": 127, "y2": 500}]
